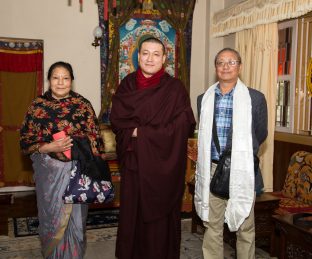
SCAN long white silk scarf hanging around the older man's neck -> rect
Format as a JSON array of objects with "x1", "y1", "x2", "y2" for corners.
[{"x1": 194, "y1": 79, "x2": 255, "y2": 231}]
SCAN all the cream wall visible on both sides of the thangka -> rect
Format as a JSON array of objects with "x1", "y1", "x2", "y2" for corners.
[{"x1": 0, "y1": 0, "x2": 235, "y2": 120}]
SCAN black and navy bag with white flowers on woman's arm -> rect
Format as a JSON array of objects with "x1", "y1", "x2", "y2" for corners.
[{"x1": 62, "y1": 138, "x2": 115, "y2": 204}]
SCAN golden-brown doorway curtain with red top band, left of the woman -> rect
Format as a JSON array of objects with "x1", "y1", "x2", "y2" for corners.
[{"x1": 0, "y1": 38, "x2": 43, "y2": 187}]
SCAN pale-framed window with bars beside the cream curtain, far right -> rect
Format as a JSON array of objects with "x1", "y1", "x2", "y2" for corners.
[{"x1": 275, "y1": 17, "x2": 312, "y2": 135}]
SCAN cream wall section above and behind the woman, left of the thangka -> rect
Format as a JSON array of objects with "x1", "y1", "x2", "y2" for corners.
[{"x1": 0, "y1": 0, "x2": 101, "y2": 114}]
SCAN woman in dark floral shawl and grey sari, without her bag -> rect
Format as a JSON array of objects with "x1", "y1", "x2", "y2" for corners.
[{"x1": 20, "y1": 62, "x2": 104, "y2": 258}]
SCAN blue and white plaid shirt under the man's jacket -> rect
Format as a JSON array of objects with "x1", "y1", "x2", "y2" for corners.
[{"x1": 211, "y1": 85, "x2": 235, "y2": 160}]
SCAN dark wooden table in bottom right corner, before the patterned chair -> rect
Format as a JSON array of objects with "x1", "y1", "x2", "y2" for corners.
[{"x1": 271, "y1": 212, "x2": 312, "y2": 259}]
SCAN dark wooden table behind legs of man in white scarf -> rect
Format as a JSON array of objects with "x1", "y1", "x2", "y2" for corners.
[{"x1": 188, "y1": 181, "x2": 280, "y2": 253}]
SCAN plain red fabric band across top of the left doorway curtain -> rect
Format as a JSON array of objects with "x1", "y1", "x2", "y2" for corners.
[{"x1": 0, "y1": 51, "x2": 43, "y2": 73}]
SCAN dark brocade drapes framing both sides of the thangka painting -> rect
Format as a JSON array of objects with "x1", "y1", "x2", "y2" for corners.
[{"x1": 98, "y1": 0, "x2": 195, "y2": 124}]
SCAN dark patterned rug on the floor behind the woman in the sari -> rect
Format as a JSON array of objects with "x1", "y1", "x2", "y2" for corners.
[{"x1": 13, "y1": 209, "x2": 119, "y2": 237}]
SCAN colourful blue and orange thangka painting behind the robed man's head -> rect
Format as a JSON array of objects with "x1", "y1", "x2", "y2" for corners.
[{"x1": 119, "y1": 18, "x2": 177, "y2": 82}]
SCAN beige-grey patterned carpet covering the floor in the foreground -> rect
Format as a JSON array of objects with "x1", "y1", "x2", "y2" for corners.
[{"x1": 0, "y1": 220, "x2": 271, "y2": 259}]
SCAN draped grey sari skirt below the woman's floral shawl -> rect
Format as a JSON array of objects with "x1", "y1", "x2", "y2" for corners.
[{"x1": 31, "y1": 153, "x2": 88, "y2": 259}]
